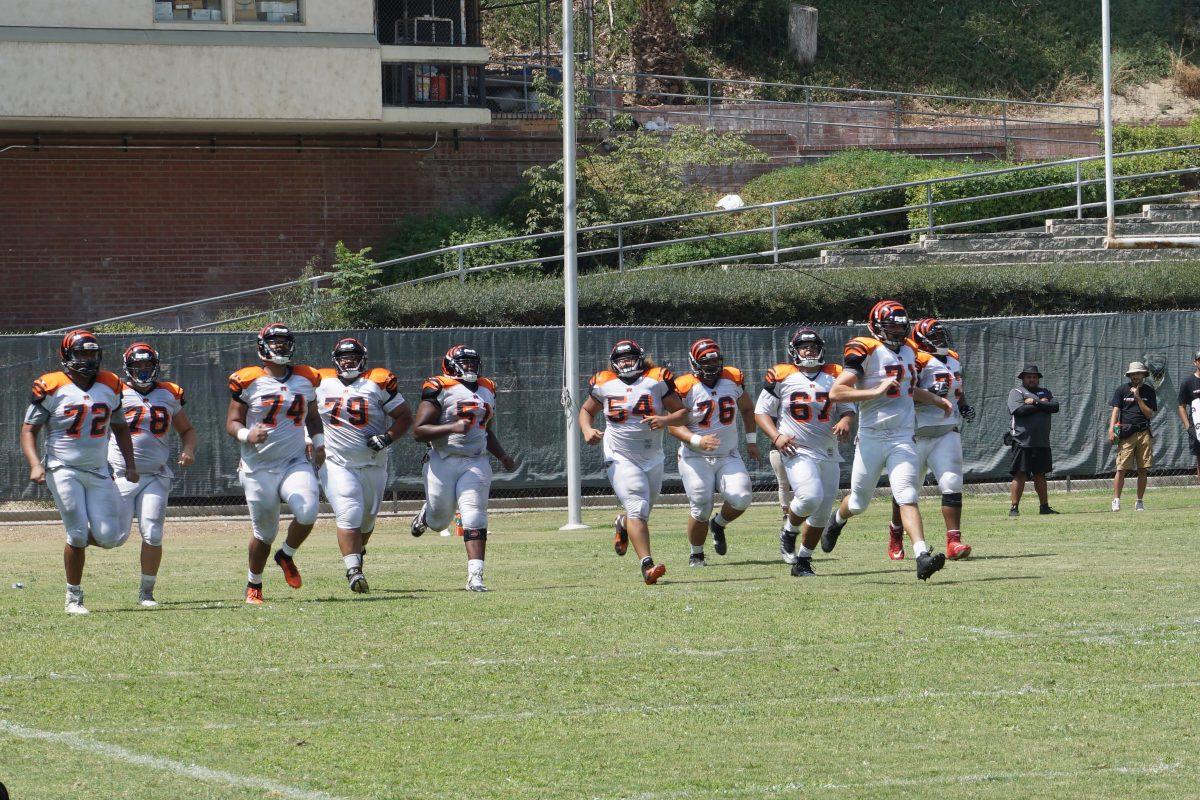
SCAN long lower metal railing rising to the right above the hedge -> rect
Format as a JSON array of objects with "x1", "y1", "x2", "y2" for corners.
[{"x1": 46, "y1": 145, "x2": 1200, "y2": 333}]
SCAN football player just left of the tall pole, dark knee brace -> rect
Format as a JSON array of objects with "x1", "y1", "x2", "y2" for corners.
[{"x1": 412, "y1": 344, "x2": 516, "y2": 591}]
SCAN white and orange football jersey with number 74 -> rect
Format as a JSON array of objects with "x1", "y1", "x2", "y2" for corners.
[{"x1": 229, "y1": 366, "x2": 320, "y2": 473}]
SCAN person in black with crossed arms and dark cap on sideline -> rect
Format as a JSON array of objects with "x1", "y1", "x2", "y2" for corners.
[{"x1": 1008, "y1": 363, "x2": 1058, "y2": 517}]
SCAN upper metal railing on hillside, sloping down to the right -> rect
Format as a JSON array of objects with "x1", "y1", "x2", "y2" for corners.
[{"x1": 487, "y1": 61, "x2": 1100, "y2": 152}]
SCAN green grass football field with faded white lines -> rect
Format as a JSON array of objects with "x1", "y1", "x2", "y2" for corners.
[{"x1": 0, "y1": 489, "x2": 1200, "y2": 800}]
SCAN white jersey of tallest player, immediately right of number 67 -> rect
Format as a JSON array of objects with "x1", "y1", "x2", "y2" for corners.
[{"x1": 845, "y1": 336, "x2": 930, "y2": 435}]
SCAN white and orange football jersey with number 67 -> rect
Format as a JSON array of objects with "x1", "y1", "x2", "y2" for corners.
[{"x1": 754, "y1": 363, "x2": 853, "y2": 462}]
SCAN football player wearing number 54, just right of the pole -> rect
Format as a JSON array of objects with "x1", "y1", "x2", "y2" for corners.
[{"x1": 578, "y1": 339, "x2": 688, "y2": 584}]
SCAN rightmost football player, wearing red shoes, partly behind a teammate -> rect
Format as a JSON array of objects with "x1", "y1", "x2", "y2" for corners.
[{"x1": 888, "y1": 317, "x2": 974, "y2": 561}]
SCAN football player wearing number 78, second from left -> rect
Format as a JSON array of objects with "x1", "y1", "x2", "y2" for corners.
[{"x1": 108, "y1": 342, "x2": 196, "y2": 608}]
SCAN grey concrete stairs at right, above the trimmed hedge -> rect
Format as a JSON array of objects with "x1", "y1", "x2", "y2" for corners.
[{"x1": 815, "y1": 204, "x2": 1200, "y2": 266}]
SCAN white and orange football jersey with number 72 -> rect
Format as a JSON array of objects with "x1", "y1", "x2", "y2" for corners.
[{"x1": 25, "y1": 369, "x2": 124, "y2": 475}]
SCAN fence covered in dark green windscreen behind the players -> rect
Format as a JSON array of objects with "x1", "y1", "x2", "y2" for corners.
[{"x1": 7, "y1": 312, "x2": 1200, "y2": 519}]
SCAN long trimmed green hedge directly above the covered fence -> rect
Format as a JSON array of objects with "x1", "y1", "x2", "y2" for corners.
[{"x1": 372, "y1": 261, "x2": 1200, "y2": 327}]
